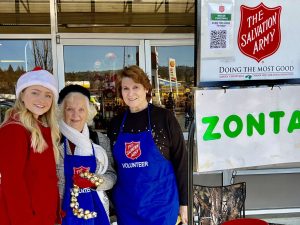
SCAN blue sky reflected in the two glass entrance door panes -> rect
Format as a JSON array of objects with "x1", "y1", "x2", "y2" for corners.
[{"x1": 64, "y1": 46, "x2": 194, "y2": 72}]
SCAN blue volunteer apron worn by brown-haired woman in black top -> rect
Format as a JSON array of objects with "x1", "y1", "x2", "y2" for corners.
[{"x1": 113, "y1": 106, "x2": 179, "y2": 225}]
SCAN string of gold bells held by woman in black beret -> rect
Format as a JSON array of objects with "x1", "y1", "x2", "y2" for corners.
[{"x1": 70, "y1": 172, "x2": 104, "y2": 220}]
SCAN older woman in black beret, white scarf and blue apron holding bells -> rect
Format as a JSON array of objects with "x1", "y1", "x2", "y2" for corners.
[{"x1": 58, "y1": 85, "x2": 116, "y2": 225}]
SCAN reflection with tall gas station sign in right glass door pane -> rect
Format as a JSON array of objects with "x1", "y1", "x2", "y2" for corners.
[{"x1": 151, "y1": 46, "x2": 195, "y2": 130}]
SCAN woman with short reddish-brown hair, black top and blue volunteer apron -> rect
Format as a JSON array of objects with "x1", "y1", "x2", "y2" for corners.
[{"x1": 108, "y1": 66, "x2": 188, "y2": 225}]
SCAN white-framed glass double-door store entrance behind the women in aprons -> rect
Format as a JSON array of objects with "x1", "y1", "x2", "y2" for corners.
[{"x1": 57, "y1": 39, "x2": 195, "y2": 132}]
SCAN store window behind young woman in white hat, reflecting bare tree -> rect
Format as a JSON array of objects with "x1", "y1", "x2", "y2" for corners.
[{"x1": 0, "y1": 40, "x2": 53, "y2": 122}]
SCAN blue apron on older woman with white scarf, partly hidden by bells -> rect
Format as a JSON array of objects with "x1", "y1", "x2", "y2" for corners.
[{"x1": 62, "y1": 138, "x2": 110, "y2": 225}]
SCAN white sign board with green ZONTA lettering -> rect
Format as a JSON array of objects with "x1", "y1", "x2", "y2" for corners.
[{"x1": 195, "y1": 86, "x2": 300, "y2": 172}]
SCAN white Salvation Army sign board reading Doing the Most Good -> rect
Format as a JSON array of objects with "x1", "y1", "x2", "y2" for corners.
[{"x1": 197, "y1": 0, "x2": 300, "y2": 82}]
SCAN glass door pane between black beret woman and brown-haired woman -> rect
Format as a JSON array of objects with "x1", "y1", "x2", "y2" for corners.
[{"x1": 64, "y1": 46, "x2": 138, "y2": 130}]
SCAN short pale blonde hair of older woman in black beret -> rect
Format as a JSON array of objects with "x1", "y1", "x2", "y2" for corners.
[{"x1": 58, "y1": 92, "x2": 97, "y2": 125}]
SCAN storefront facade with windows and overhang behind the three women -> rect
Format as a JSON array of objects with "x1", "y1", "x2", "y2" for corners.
[{"x1": 0, "y1": 0, "x2": 196, "y2": 130}]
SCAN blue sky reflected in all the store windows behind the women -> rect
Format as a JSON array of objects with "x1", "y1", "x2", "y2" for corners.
[{"x1": 0, "y1": 40, "x2": 194, "y2": 72}]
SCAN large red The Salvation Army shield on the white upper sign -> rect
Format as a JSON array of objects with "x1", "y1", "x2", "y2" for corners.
[{"x1": 237, "y1": 3, "x2": 281, "y2": 62}]
